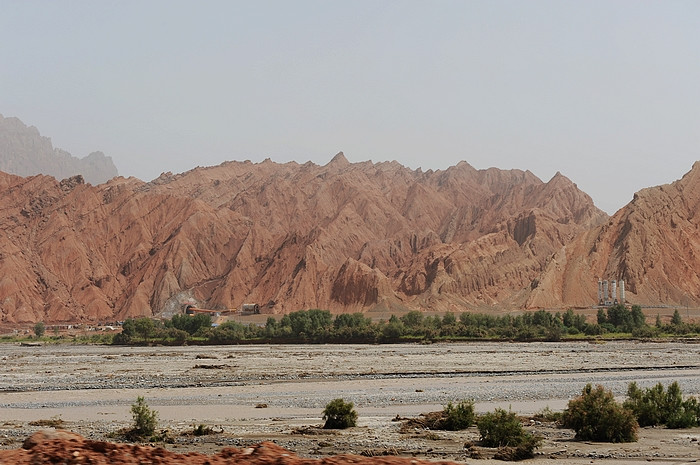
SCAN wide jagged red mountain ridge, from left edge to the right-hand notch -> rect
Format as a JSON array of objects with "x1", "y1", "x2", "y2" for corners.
[{"x1": 0, "y1": 153, "x2": 608, "y2": 323}]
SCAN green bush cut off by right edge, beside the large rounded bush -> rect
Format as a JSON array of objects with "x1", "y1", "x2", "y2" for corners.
[{"x1": 623, "y1": 381, "x2": 700, "y2": 428}]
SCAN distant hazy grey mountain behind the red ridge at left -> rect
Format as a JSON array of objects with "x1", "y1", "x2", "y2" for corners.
[{"x1": 0, "y1": 115, "x2": 117, "y2": 184}]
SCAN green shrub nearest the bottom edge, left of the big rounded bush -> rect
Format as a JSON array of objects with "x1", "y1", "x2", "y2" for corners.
[{"x1": 476, "y1": 408, "x2": 541, "y2": 460}]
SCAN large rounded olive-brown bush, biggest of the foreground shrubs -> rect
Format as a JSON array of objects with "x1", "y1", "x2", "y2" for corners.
[{"x1": 562, "y1": 383, "x2": 638, "y2": 442}]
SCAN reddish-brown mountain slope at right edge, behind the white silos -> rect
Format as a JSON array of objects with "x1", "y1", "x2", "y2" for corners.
[{"x1": 527, "y1": 162, "x2": 700, "y2": 307}]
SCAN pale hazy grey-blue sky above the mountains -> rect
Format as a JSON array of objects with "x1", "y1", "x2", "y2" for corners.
[{"x1": 0, "y1": 0, "x2": 700, "y2": 213}]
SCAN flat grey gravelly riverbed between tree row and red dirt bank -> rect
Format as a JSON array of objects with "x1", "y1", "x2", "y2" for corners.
[{"x1": 0, "y1": 342, "x2": 700, "y2": 464}]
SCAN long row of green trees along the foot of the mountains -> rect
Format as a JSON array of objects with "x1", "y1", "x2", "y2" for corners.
[{"x1": 114, "y1": 305, "x2": 700, "y2": 344}]
